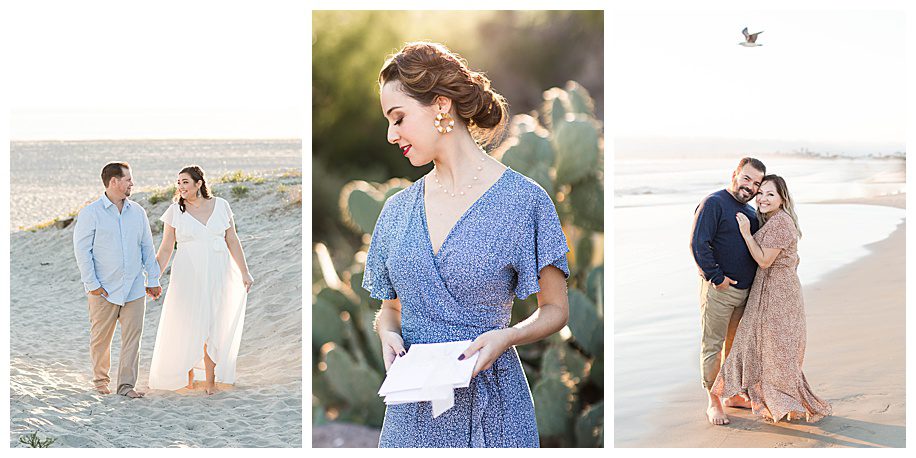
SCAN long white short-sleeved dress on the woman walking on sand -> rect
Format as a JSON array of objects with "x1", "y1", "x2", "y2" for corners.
[{"x1": 149, "y1": 197, "x2": 248, "y2": 390}]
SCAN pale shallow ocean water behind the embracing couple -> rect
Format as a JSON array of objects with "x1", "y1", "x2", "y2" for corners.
[{"x1": 614, "y1": 154, "x2": 906, "y2": 445}]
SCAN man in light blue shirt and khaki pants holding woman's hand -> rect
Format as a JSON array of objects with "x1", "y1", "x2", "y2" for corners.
[{"x1": 73, "y1": 162, "x2": 162, "y2": 398}]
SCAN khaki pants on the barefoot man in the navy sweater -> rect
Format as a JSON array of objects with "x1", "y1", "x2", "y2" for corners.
[{"x1": 700, "y1": 277, "x2": 749, "y2": 390}]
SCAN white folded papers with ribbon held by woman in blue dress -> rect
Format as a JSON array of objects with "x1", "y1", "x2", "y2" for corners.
[{"x1": 378, "y1": 340, "x2": 478, "y2": 418}]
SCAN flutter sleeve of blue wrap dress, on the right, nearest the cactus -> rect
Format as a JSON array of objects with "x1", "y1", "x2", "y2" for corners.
[{"x1": 513, "y1": 188, "x2": 569, "y2": 299}]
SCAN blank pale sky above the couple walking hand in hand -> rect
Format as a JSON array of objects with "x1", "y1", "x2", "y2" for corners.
[{"x1": 4, "y1": 0, "x2": 310, "y2": 140}]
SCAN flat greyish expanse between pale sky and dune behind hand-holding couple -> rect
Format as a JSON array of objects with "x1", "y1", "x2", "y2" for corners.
[{"x1": 10, "y1": 139, "x2": 302, "y2": 231}]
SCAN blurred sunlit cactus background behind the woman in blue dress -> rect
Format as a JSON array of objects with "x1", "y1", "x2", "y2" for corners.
[{"x1": 311, "y1": 9, "x2": 604, "y2": 447}]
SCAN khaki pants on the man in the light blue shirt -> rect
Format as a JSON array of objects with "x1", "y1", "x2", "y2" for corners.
[{"x1": 89, "y1": 294, "x2": 146, "y2": 394}]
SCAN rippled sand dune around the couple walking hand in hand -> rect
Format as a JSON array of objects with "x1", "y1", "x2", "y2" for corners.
[{"x1": 10, "y1": 173, "x2": 302, "y2": 447}]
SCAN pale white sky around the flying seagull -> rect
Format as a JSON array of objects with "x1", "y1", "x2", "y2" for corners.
[{"x1": 606, "y1": 10, "x2": 907, "y2": 148}]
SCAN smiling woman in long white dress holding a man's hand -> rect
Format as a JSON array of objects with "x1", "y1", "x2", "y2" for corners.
[{"x1": 149, "y1": 165, "x2": 254, "y2": 394}]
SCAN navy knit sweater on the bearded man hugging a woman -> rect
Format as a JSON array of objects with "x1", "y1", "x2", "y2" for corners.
[{"x1": 690, "y1": 189, "x2": 759, "y2": 289}]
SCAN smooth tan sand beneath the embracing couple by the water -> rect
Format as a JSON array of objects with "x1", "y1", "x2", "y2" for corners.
[{"x1": 615, "y1": 194, "x2": 906, "y2": 447}]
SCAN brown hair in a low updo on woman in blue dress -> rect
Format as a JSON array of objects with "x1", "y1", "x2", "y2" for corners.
[{"x1": 378, "y1": 41, "x2": 509, "y2": 144}]
